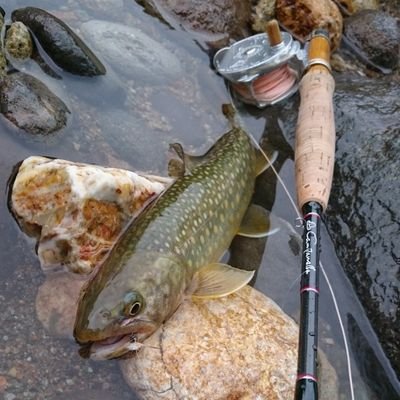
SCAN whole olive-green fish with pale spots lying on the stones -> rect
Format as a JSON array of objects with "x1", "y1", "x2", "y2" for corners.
[{"x1": 74, "y1": 106, "x2": 269, "y2": 359}]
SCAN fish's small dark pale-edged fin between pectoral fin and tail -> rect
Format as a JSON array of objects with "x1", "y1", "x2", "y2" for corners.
[{"x1": 237, "y1": 204, "x2": 276, "y2": 238}]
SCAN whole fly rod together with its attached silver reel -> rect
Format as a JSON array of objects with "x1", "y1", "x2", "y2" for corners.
[{"x1": 214, "y1": 20, "x2": 338, "y2": 400}]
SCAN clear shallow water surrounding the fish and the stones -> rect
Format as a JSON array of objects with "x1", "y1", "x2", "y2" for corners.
[{"x1": 0, "y1": 0, "x2": 399, "y2": 400}]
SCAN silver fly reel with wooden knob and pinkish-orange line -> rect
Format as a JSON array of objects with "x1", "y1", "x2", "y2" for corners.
[{"x1": 214, "y1": 20, "x2": 306, "y2": 108}]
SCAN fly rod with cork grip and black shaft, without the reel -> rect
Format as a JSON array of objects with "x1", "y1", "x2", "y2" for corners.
[{"x1": 295, "y1": 30, "x2": 335, "y2": 400}]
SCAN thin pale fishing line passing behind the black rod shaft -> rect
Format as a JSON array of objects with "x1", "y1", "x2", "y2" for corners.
[{"x1": 249, "y1": 128, "x2": 355, "y2": 400}]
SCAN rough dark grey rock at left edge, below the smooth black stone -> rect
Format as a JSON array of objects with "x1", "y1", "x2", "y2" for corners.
[{"x1": 0, "y1": 72, "x2": 69, "y2": 135}]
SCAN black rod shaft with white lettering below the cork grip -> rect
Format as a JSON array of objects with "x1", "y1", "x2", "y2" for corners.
[{"x1": 295, "y1": 201, "x2": 322, "y2": 400}]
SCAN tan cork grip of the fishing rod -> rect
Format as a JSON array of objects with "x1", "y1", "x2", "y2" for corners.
[{"x1": 295, "y1": 66, "x2": 335, "y2": 210}]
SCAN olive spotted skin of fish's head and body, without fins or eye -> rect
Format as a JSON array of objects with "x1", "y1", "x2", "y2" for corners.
[{"x1": 74, "y1": 127, "x2": 257, "y2": 343}]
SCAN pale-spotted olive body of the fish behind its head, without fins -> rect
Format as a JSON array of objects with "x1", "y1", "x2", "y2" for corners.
[{"x1": 124, "y1": 128, "x2": 256, "y2": 271}]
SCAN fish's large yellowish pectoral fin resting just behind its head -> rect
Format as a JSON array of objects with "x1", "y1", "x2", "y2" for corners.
[{"x1": 192, "y1": 263, "x2": 254, "y2": 298}]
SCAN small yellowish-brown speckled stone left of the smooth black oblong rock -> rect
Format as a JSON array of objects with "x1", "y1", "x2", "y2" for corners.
[{"x1": 5, "y1": 22, "x2": 33, "y2": 60}]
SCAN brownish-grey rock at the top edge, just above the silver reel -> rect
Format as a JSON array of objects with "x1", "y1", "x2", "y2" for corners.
[{"x1": 143, "y1": 0, "x2": 251, "y2": 39}]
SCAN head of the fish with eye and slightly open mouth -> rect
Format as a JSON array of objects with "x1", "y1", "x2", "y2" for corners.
[{"x1": 74, "y1": 251, "x2": 189, "y2": 359}]
